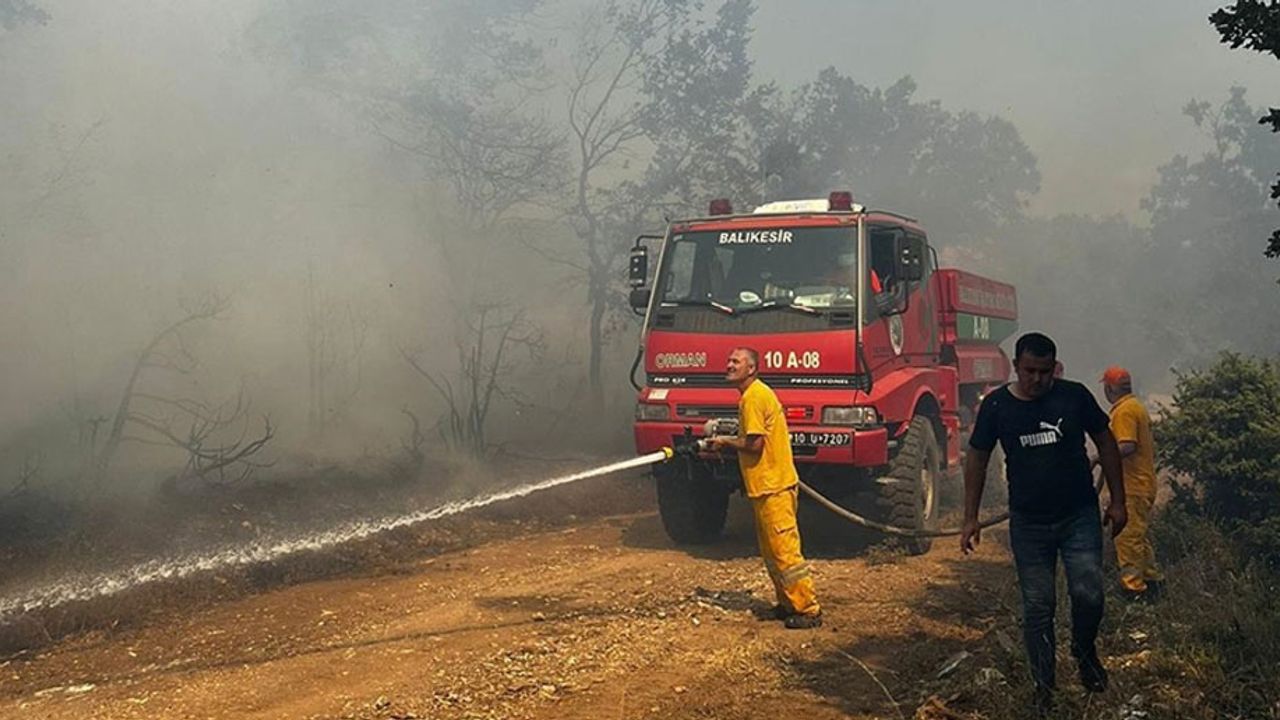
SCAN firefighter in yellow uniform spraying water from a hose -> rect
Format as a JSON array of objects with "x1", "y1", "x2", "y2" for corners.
[{"x1": 712, "y1": 347, "x2": 822, "y2": 629}]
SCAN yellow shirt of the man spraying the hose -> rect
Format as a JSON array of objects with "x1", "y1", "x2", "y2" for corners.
[{"x1": 737, "y1": 379, "x2": 800, "y2": 497}]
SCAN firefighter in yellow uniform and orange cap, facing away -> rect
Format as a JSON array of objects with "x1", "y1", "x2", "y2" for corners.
[{"x1": 1102, "y1": 366, "x2": 1164, "y2": 598}]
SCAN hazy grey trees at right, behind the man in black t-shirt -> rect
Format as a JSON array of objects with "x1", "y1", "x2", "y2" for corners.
[{"x1": 962, "y1": 88, "x2": 1280, "y2": 388}]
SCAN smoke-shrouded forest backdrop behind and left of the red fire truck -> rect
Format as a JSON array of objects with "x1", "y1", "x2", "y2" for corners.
[{"x1": 0, "y1": 0, "x2": 1280, "y2": 499}]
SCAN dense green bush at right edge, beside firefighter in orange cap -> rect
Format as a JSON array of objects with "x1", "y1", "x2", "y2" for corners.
[{"x1": 1156, "y1": 352, "x2": 1280, "y2": 561}]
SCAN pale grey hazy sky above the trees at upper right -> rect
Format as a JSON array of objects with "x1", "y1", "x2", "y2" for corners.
[{"x1": 753, "y1": 0, "x2": 1280, "y2": 220}]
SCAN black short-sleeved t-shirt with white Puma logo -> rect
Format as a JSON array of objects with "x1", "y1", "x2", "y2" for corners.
[{"x1": 969, "y1": 380, "x2": 1110, "y2": 519}]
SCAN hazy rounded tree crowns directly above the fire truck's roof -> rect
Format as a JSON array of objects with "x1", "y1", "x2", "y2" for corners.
[{"x1": 750, "y1": 68, "x2": 1039, "y2": 243}]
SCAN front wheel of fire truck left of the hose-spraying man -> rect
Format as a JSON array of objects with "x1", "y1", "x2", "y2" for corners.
[{"x1": 654, "y1": 461, "x2": 730, "y2": 544}]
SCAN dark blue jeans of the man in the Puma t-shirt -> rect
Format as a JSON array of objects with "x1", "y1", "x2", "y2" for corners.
[{"x1": 1009, "y1": 505, "x2": 1102, "y2": 688}]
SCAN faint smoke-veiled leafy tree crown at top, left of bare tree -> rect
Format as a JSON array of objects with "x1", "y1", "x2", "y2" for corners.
[{"x1": 248, "y1": 0, "x2": 563, "y2": 228}]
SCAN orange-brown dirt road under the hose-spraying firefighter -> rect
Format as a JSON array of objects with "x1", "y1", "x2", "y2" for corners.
[{"x1": 0, "y1": 471, "x2": 1012, "y2": 719}]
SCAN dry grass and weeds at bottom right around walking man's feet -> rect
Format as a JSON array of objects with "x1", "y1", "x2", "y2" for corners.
[{"x1": 922, "y1": 510, "x2": 1280, "y2": 720}]
